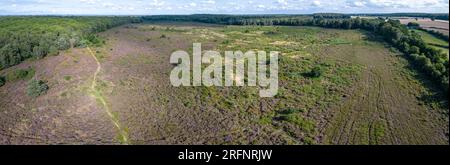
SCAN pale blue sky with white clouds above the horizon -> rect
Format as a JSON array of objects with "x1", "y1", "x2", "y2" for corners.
[{"x1": 0, "y1": 0, "x2": 449, "y2": 15}]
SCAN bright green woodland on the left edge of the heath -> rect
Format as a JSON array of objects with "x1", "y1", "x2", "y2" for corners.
[{"x1": 0, "y1": 16, "x2": 140, "y2": 69}]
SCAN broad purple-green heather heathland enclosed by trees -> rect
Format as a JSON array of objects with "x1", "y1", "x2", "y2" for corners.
[{"x1": 0, "y1": 22, "x2": 448, "y2": 144}]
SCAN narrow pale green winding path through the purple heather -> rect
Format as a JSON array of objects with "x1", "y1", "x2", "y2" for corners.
[{"x1": 87, "y1": 47, "x2": 129, "y2": 144}]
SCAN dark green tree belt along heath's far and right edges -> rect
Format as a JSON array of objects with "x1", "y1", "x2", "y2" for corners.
[{"x1": 143, "y1": 14, "x2": 449, "y2": 93}]
